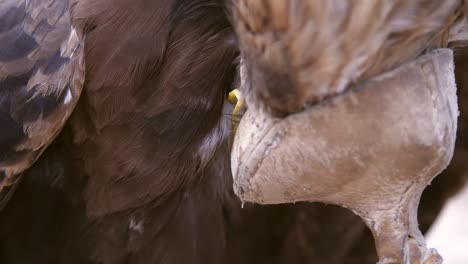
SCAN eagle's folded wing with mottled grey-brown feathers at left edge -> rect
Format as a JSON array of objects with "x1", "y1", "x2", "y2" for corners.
[{"x1": 0, "y1": 0, "x2": 85, "y2": 208}]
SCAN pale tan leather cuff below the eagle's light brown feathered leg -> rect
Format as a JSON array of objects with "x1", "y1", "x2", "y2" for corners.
[{"x1": 232, "y1": 49, "x2": 458, "y2": 263}]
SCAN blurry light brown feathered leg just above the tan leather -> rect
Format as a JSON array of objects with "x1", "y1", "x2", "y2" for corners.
[{"x1": 232, "y1": 0, "x2": 463, "y2": 114}]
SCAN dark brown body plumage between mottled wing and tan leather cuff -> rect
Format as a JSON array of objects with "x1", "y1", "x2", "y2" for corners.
[{"x1": 0, "y1": 0, "x2": 466, "y2": 264}]
